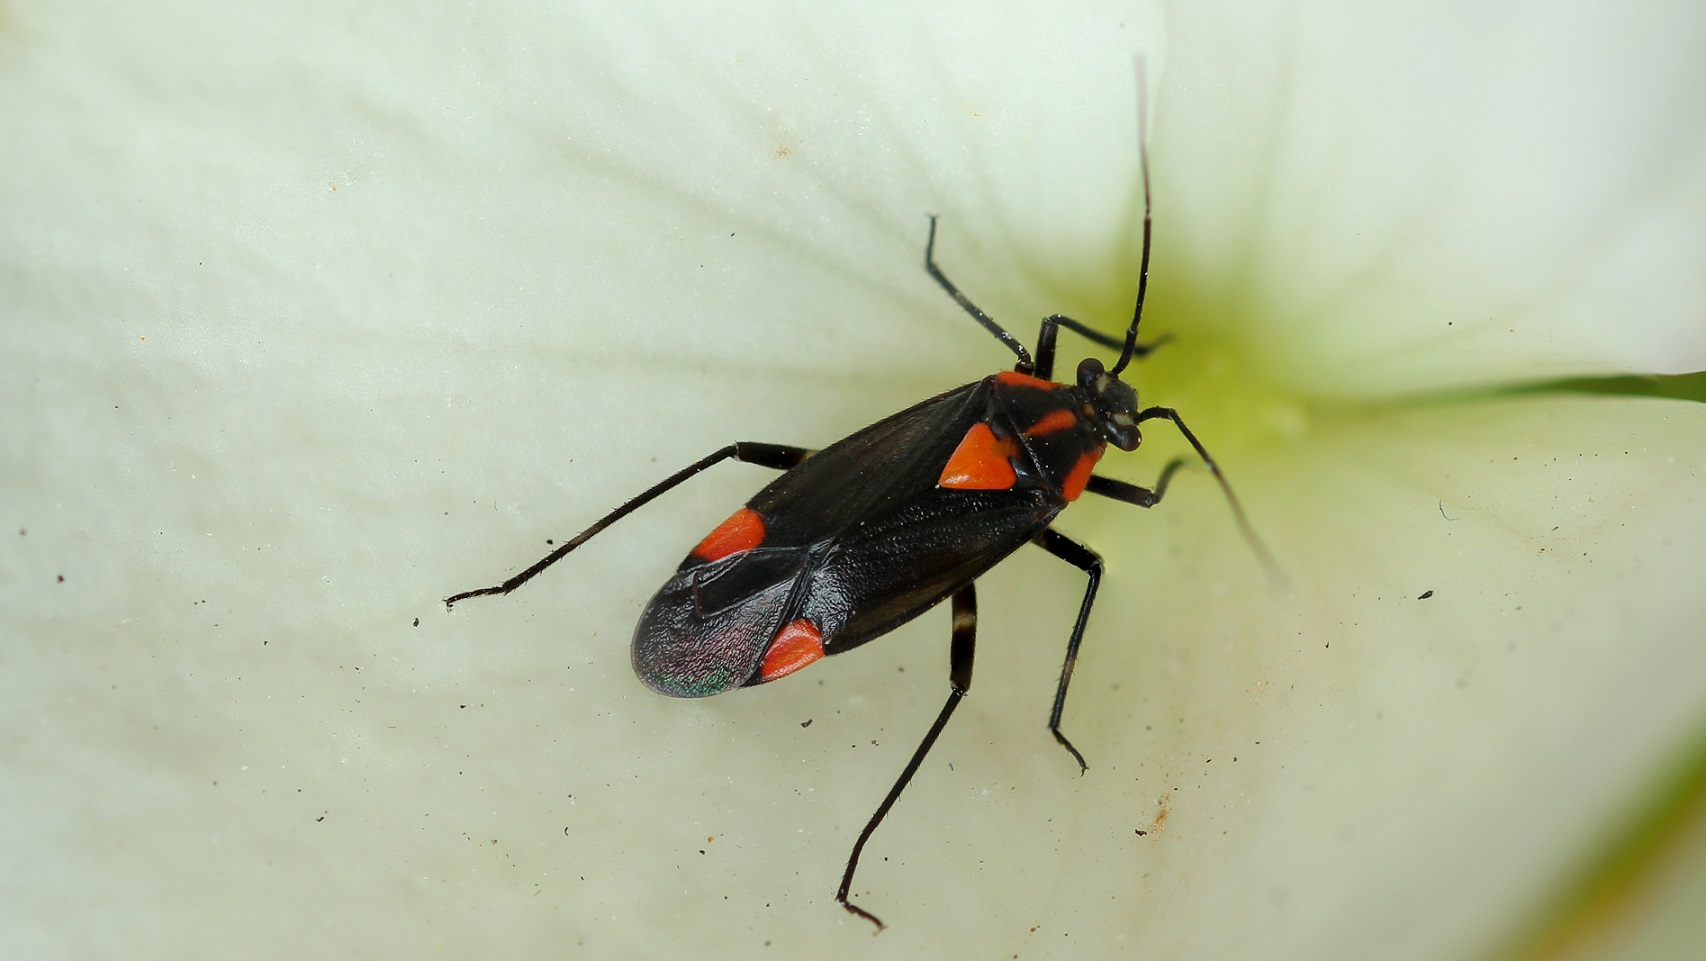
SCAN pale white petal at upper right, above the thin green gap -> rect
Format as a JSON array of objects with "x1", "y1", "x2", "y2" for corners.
[{"x1": 1155, "y1": 2, "x2": 1706, "y2": 396}]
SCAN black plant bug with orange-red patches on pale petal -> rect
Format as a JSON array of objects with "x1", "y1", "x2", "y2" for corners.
[{"x1": 445, "y1": 99, "x2": 1266, "y2": 930}]
